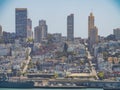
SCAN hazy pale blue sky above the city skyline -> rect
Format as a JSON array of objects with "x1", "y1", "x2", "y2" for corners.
[{"x1": 0, "y1": 0, "x2": 120, "y2": 37}]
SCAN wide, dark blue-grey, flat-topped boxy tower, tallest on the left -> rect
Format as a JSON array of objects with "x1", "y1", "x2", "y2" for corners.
[{"x1": 15, "y1": 8, "x2": 27, "y2": 38}]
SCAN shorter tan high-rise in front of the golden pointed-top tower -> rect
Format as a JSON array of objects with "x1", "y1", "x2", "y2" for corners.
[{"x1": 89, "y1": 27, "x2": 98, "y2": 48}]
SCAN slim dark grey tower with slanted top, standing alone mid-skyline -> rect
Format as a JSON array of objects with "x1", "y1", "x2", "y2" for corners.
[{"x1": 67, "y1": 14, "x2": 74, "y2": 41}]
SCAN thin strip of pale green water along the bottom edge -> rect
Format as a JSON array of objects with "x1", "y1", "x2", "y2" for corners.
[{"x1": 2, "y1": 88, "x2": 103, "y2": 90}]
